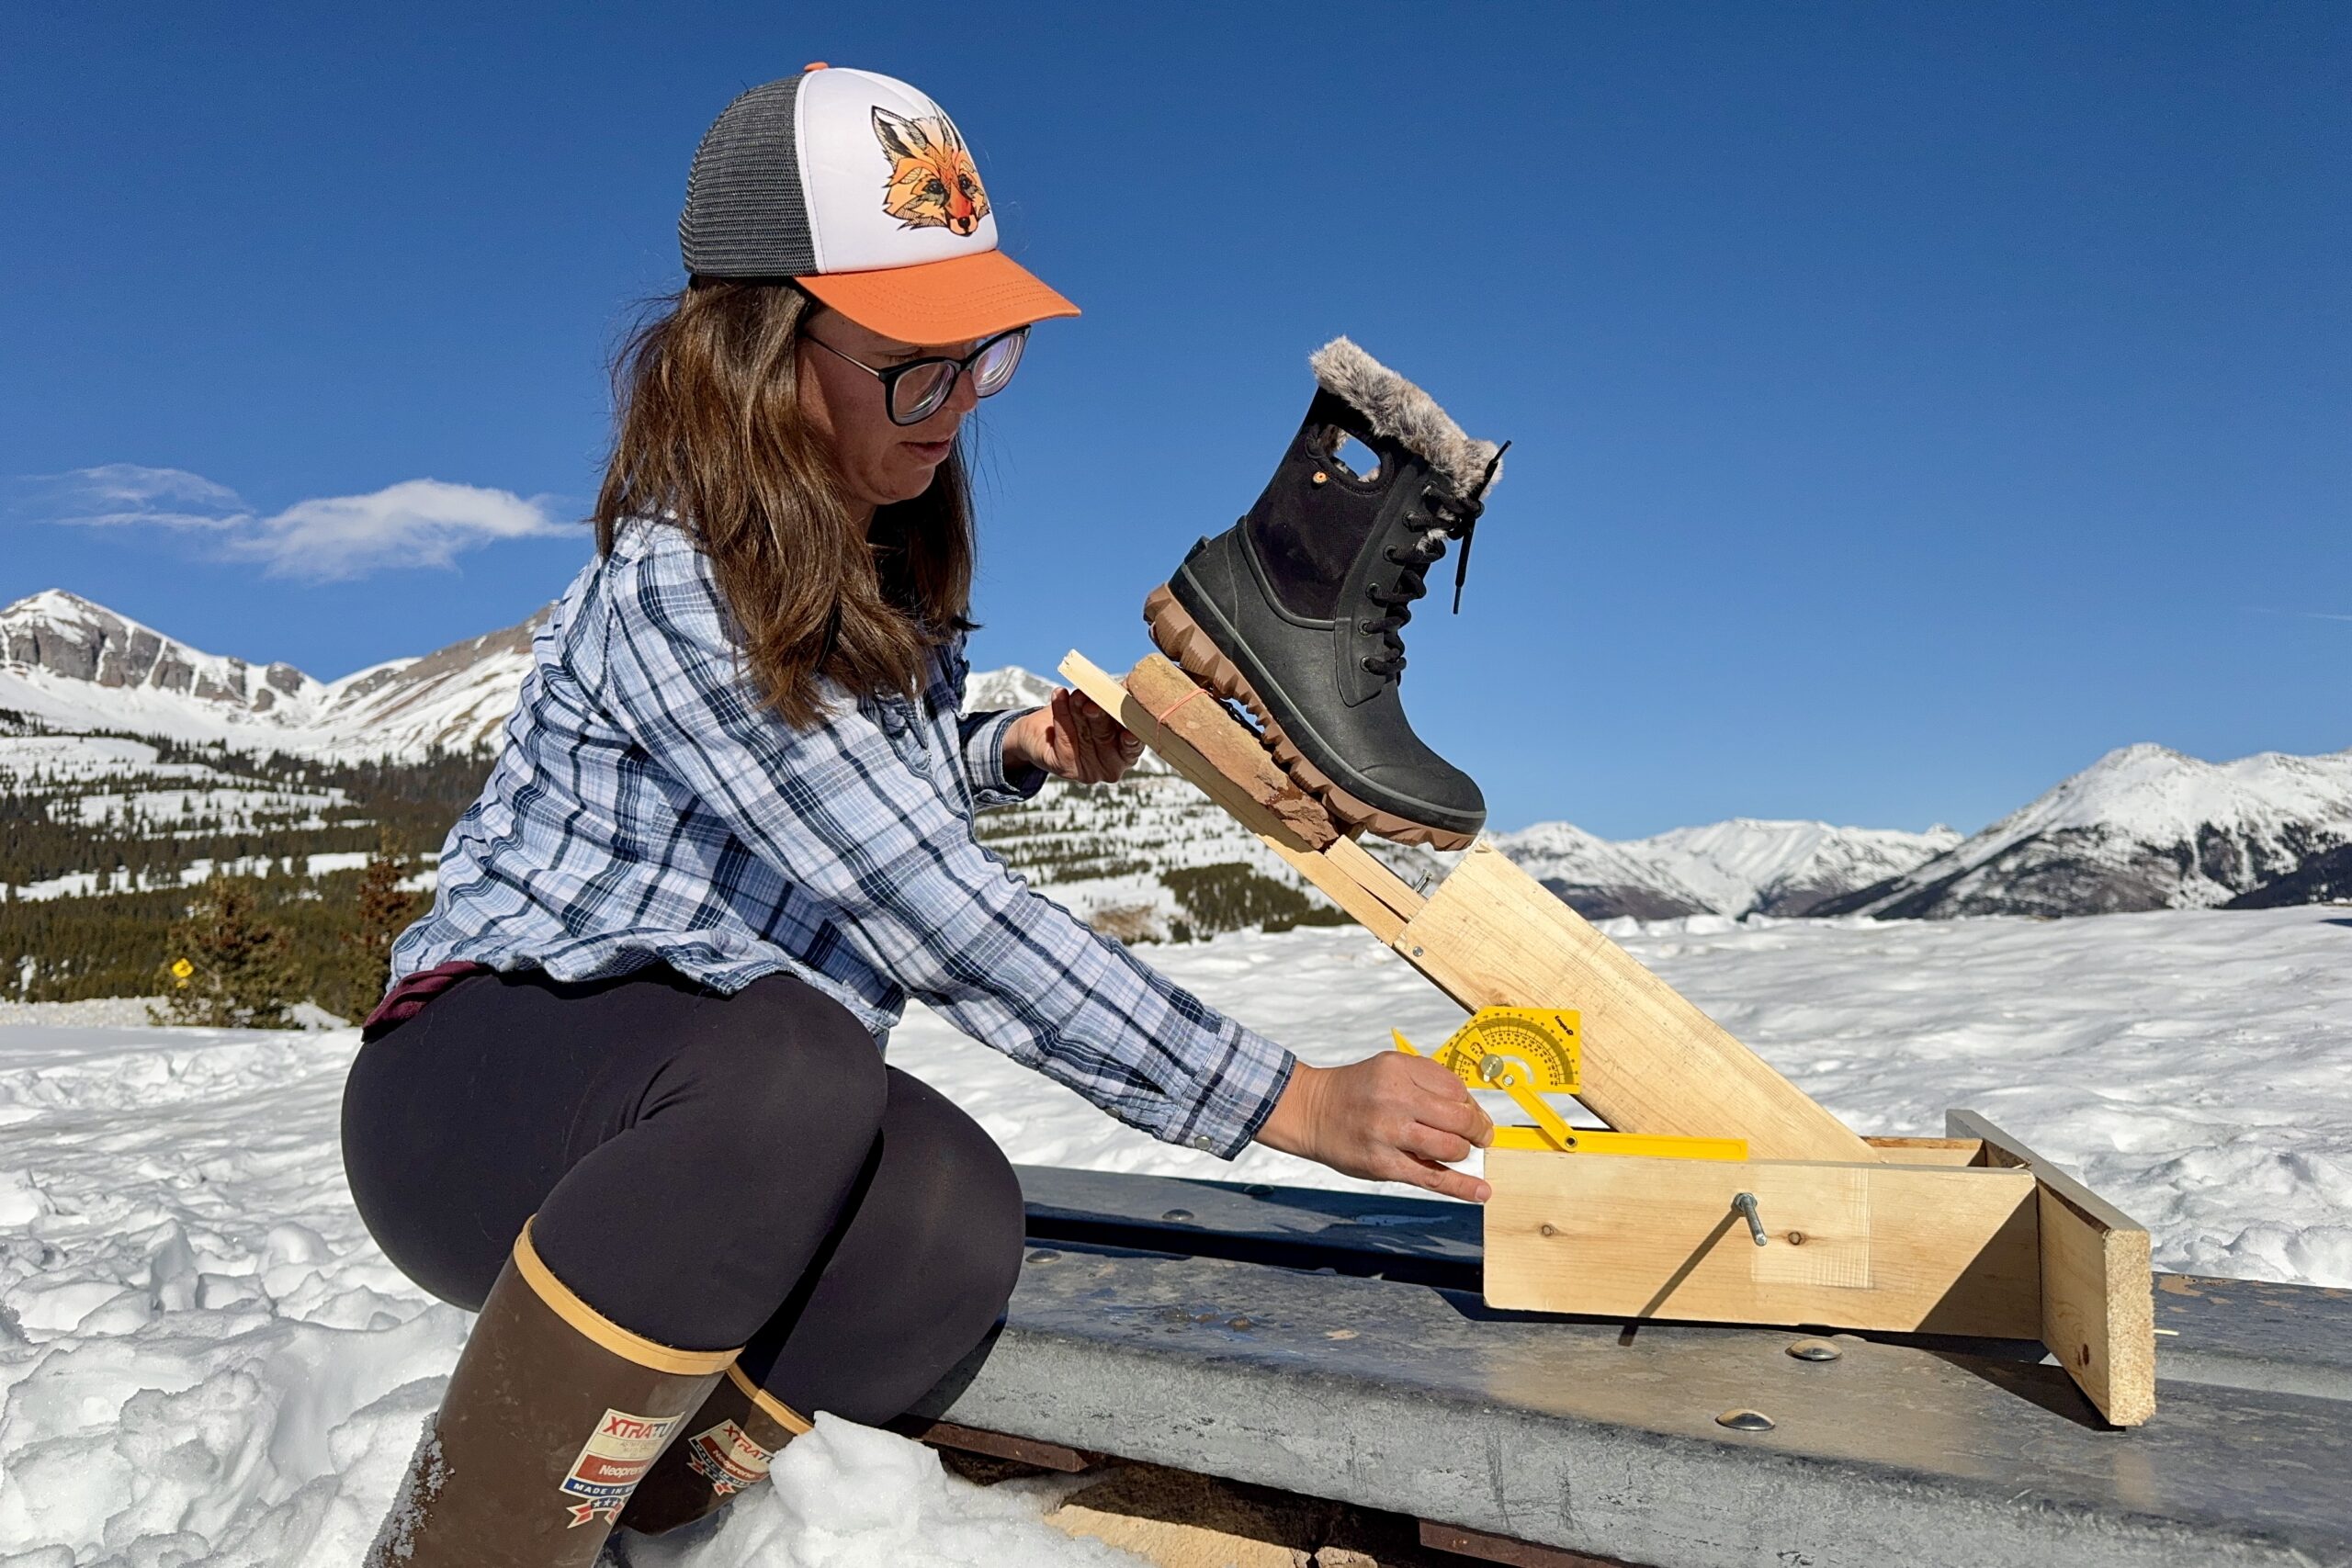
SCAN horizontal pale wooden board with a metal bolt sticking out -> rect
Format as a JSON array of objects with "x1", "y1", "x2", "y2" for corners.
[{"x1": 1487, "y1": 1149, "x2": 2041, "y2": 1340}]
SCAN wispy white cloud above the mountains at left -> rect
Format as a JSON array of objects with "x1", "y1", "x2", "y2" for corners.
[{"x1": 9, "y1": 463, "x2": 571, "y2": 583}]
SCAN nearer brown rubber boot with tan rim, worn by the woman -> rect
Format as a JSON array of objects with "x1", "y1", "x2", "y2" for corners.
[{"x1": 367, "y1": 1224, "x2": 736, "y2": 1568}]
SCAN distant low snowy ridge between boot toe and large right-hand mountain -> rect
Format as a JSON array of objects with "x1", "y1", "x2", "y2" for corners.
[{"x1": 1496, "y1": 816, "x2": 1959, "y2": 919}]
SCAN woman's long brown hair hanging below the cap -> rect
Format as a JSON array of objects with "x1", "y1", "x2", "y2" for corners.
[{"x1": 595, "y1": 280, "x2": 971, "y2": 728}]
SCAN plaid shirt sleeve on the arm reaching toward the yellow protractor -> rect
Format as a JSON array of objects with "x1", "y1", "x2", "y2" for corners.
[{"x1": 582, "y1": 547, "x2": 1294, "y2": 1159}]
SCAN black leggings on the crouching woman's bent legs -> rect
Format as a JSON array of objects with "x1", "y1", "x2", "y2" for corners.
[{"x1": 344, "y1": 968, "x2": 1021, "y2": 1422}]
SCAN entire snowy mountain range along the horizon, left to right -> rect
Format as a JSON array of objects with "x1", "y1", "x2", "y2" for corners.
[{"x1": 0, "y1": 590, "x2": 2352, "y2": 936}]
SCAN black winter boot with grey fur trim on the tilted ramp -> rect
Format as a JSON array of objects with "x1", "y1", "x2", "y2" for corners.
[{"x1": 1143, "y1": 339, "x2": 1503, "y2": 849}]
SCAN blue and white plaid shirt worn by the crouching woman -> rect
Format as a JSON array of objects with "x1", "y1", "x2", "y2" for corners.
[{"x1": 393, "y1": 525, "x2": 1291, "y2": 1156}]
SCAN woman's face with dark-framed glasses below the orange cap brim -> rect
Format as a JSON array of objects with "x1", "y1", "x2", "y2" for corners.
[{"x1": 797, "y1": 310, "x2": 978, "y2": 508}]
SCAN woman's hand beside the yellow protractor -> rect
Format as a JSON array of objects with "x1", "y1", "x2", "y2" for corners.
[{"x1": 1259, "y1": 1051, "x2": 1494, "y2": 1203}]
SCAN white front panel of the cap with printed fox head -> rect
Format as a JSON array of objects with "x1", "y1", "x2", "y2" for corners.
[{"x1": 793, "y1": 68, "x2": 997, "y2": 273}]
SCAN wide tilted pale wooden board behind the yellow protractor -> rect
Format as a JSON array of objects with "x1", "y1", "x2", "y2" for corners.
[{"x1": 1390, "y1": 840, "x2": 1879, "y2": 1164}]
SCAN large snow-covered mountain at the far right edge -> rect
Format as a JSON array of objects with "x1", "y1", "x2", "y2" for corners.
[{"x1": 1823, "y1": 745, "x2": 2352, "y2": 919}]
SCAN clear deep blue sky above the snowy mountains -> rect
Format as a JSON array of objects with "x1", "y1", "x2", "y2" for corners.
[{"x1": 0, "y1": 5, "x2": 2352, "y2": 837}]
